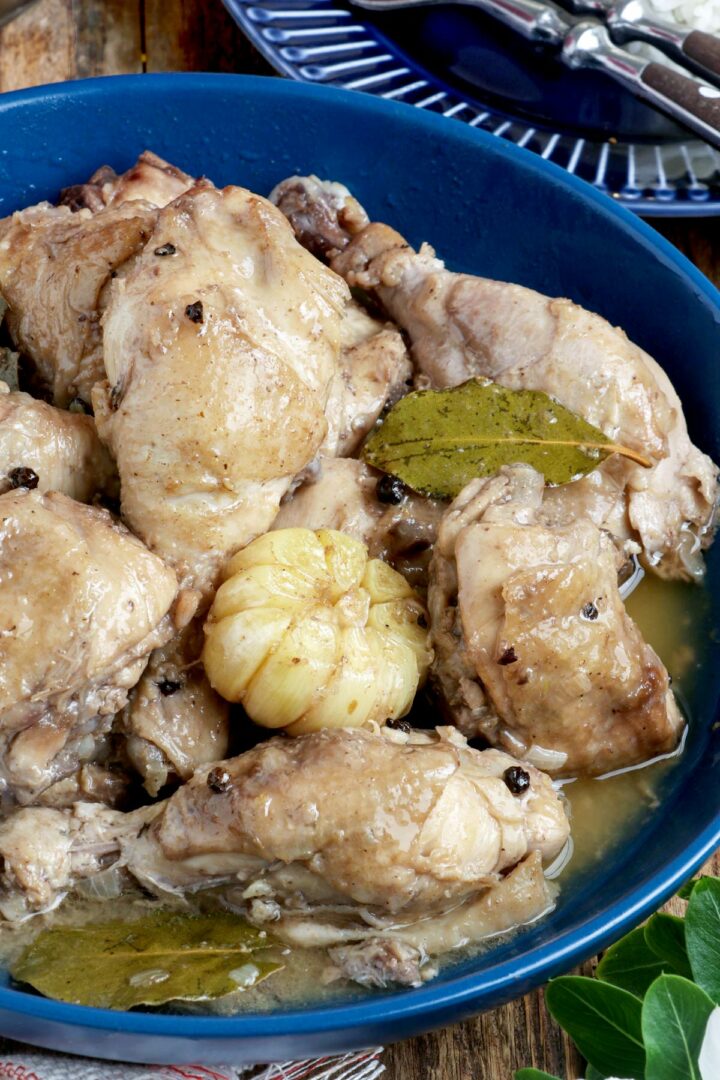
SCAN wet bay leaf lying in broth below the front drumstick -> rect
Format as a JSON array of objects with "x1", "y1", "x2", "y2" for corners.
[{"x1": 11, "y1": 912, "x2": 283, "y2": 1009}]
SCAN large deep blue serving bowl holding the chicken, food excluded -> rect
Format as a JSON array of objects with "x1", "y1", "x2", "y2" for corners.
[{"x1": 0, "y1": 75, "x2": 720, "y2": 1063}]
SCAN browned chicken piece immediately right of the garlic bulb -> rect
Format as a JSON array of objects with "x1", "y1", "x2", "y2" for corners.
[{"x1": 427, "y1": 465, "x2": 683, "y2": 777}]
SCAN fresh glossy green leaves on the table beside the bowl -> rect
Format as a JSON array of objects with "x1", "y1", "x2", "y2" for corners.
[{"x1": 515, "y1": 877, "x2": 720, "y2": 1080}]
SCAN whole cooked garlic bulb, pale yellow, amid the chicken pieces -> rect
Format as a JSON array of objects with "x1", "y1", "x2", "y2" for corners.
[{"x1": 203, "y1": 528, "x2": 431, "y2": 734}]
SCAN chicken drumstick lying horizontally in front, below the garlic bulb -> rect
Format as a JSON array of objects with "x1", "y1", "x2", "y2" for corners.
[{"x1": 0, "y1": 729, "x2": 569, "y2": 984}]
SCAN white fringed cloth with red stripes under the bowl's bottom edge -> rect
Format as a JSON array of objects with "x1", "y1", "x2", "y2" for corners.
[{"x1": 0, "y1": 1042, "x2": 385, "y2": 1080}]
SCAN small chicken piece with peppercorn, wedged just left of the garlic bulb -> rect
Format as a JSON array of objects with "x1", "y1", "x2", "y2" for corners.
[{"x1": 116, "y1": 620, "x2": 230, "y2": 795}]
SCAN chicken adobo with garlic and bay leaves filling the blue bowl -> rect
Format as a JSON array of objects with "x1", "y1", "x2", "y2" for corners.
[{"x1": 0, "y1": 151, "x2": 718, "y2": 1008}]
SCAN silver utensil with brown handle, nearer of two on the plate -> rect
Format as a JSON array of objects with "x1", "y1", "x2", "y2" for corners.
[{"x1": 352, "y1": 0, "x2": 720, "y2": 149}]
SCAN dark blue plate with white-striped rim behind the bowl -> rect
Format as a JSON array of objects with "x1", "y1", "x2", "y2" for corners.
[{"x1": 225, "y1": 0, "x2": 720, "y2": 217}]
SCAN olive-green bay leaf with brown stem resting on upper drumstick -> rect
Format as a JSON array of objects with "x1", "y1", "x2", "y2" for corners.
[{"x1": 362, "y1": 379, "x2": 652, "y2": 499}]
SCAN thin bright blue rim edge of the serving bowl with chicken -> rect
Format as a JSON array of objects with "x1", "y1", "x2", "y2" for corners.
[{"x1": 0, "y1": 72, "x2": 720, "y2": 1040}]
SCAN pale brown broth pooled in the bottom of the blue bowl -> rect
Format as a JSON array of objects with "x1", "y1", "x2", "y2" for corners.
[{"x1": 0, "y1": 576, "x2": 708, "y2": 1015}]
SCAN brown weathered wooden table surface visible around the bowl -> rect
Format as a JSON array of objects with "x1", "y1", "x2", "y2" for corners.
[{"x1": 0, "y1": 0, "x2": 720, "y2": 1080}]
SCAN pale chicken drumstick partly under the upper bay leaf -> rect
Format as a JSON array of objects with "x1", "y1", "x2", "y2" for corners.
[{"x1": 273, "y1": 176, "x2": 718, "y2": 578}]
